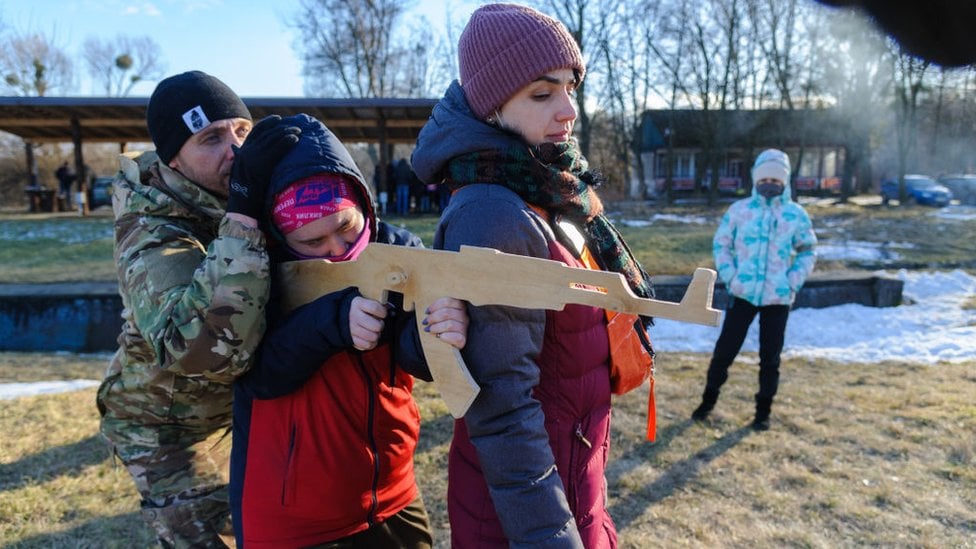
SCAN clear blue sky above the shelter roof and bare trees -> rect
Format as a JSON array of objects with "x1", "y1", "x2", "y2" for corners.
[{"x1": 0, "y1": 0, "x2": 478, "y2": 97}]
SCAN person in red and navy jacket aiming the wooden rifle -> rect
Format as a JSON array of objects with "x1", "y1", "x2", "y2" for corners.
[{"x1": 231, "y1": 115, "x2": 467, "y2": 548}]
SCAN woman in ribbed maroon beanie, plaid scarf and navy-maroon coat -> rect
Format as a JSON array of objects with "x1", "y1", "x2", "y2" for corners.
[{"x1": 413, "y1": 4, "x2": 653, "y2": 548}]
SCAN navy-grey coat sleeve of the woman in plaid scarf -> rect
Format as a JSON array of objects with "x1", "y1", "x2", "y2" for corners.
[{"x1": 435, "y1": 185, "x2": 582, "y2": 547}]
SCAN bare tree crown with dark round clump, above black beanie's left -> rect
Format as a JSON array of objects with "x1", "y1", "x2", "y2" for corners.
[{"x1": 82, "y1": 34, "x2": 166, "y2": 97}]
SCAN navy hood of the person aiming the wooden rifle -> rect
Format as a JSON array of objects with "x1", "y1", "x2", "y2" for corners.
[{"x1": 264, "y1": 114, "x2": 377, "y2": 242}]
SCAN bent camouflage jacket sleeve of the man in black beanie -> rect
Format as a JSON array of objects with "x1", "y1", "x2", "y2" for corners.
[{"x1": 117, "y1": 217, "x2": 270, "y2": 383}]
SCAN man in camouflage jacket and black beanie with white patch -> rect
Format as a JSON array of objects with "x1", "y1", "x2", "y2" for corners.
[{"x1": 97, "y1": 71, "x2": 298, "y2": 547}]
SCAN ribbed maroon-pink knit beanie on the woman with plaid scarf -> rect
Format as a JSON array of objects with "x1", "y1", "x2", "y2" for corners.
[{"x1": 458, "y1": 4, "x2": 586, "y2": 119}]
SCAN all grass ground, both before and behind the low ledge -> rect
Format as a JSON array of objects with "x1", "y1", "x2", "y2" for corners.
[{"x1": 0, "y1": 204, "x2": 976, "y2": 548}]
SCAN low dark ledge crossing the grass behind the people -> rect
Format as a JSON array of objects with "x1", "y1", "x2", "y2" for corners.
[{"x1": 0, "y1": 272, "x2": 903, "y2": 353}]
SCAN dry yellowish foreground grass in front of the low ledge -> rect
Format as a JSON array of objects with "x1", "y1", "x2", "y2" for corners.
[{"x1": 0, "y1": 352, "x2": 976, "y2": 548}]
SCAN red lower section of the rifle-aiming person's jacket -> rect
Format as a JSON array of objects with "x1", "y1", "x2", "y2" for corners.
[{"x1": 241, "y1": 340, "x2": 420, "y2": 547}]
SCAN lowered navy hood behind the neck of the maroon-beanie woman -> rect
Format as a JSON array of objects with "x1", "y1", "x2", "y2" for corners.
[{"x1": 410, "y1": 80, "x2": 526, "y2": 183}]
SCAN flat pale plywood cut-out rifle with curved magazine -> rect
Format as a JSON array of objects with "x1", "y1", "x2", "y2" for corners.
[{"x1": 276, "y1": 242, "x2": 721, "y2": 418}]
